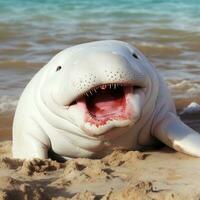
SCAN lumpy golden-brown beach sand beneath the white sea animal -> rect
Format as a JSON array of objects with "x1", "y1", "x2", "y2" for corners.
[{"x1": 0, "y1": 111, "x2": 200, "y2": 200}]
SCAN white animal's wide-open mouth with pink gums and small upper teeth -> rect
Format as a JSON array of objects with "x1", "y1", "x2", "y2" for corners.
[{"x1": 73, "y1": 83, "x2": 136, "y2": 126}]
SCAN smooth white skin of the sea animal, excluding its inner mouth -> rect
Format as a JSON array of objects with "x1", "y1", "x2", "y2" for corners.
[{"x1": 13, "y1": 40, "x2": 200, "y2": 159}]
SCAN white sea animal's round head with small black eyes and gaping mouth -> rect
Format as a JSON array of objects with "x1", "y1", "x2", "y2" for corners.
[{"x1": 38, "y1": 40, "x2": 159, "y2": 157}]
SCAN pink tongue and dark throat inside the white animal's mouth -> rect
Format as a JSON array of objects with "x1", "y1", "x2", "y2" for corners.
[{"x1": 87, "y1": 89, "x2": 125, "y2": 118}]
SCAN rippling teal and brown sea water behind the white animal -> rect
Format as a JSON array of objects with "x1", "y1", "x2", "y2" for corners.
[{"x1": 0, "y1": 0, "x2": 200, "y2": 137}]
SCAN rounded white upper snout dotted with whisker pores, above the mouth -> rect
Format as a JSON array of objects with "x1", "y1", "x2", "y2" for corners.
[{"x1": 66, "y1": 52, "x2": 146, "y2": 108}]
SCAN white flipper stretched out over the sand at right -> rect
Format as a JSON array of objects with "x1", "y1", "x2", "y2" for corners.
[{"x1": 153, "y1": 112, "x2": 200, "y2": 157}]
